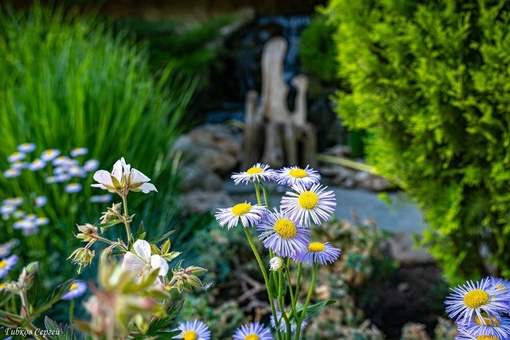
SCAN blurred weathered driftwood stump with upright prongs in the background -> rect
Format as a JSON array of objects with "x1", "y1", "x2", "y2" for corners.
[{"x1": 242, "y1": 37, "x2": 317, "y2": 169}]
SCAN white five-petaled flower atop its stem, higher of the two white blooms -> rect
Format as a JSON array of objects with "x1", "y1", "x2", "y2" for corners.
[{"x1": 92, "y1": 157, "x2": 158, "y2": 196}]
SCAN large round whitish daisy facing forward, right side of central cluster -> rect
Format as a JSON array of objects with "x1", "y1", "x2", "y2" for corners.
[{"x1": 281, "y1": 183, "x2": 336, "y2": 226}]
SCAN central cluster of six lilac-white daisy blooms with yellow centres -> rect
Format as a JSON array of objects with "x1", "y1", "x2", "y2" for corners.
[{"x1": 215, "y1": 163, "x2": 340, "y2": 264}]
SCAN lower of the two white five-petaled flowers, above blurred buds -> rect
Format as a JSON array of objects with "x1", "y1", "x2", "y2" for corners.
[{"x1": 122, "y1": 240, "x2": 168, "y2": 282}]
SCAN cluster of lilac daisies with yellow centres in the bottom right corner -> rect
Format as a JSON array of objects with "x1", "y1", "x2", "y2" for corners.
[{"x1": 445, "y1": 277, "x2": 510, "y2": 340}]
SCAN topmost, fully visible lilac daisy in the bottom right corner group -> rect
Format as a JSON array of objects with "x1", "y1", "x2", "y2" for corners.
[{"x1": 445, "y1": 277, "x2": 510, "y2": 325}]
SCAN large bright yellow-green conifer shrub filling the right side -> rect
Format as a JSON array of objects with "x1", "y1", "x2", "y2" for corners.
[{"x1": 323, "y1": 0, "x2": 510, "y2": 283}]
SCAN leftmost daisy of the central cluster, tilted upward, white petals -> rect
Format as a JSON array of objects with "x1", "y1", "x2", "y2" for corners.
[{"x1": 215, "y1": 202, "x2": 266, "y2": 229}]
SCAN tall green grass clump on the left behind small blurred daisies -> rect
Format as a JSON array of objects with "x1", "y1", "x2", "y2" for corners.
[{"x1": 0, "y1": 6, "x2": 196, "y2": 286}]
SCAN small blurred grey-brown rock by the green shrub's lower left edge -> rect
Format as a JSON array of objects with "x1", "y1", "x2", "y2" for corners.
[{"x1": 389, "y1": 232, "x2": 435, "y2": 265}]
